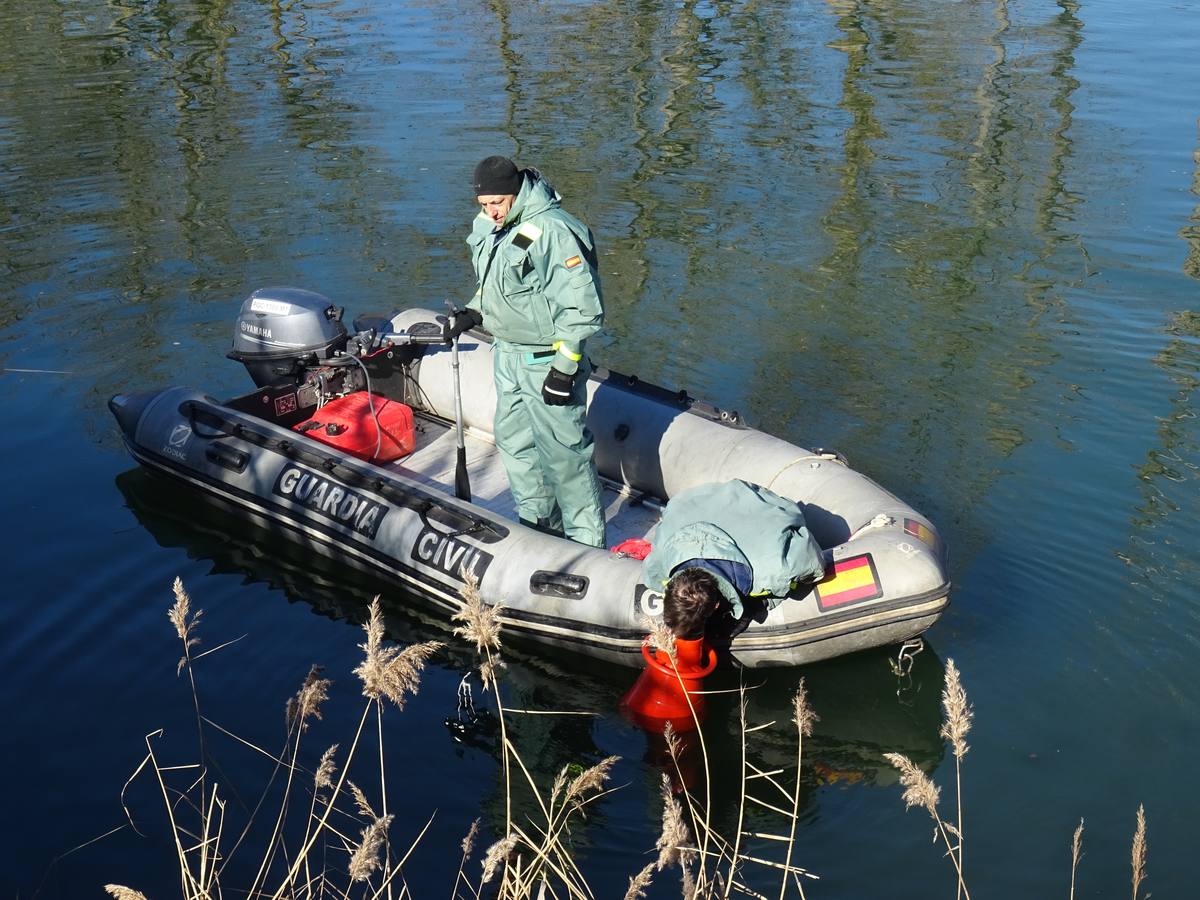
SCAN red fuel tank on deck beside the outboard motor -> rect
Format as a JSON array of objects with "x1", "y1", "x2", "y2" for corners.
[{"x1": 293, "y1": 391, "x2": 416, "y2": 462}]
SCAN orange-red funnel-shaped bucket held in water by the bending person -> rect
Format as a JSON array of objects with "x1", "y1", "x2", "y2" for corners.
[{"x1": 620, "y1": 637, "x2": 716, "y2": 732}]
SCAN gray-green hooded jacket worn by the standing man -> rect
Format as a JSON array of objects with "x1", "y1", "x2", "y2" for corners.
[{"x1": 467, "y1": 169, "x2": 604, "y2": 374}]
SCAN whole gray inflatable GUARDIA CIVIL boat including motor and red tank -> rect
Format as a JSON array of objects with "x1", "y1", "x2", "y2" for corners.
[{"x1": 109, "y1": 288, "x2": 950, "y2": 667}]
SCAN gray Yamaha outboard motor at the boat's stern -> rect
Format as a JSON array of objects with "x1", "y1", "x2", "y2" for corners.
[{"x1": 227, "y1": 287, "x2": 347, "y2": 388}]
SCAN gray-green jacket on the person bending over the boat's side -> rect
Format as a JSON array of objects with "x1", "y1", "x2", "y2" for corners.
[{"x1": 642, "y1": 480, "x2": 824, "y2": 618}]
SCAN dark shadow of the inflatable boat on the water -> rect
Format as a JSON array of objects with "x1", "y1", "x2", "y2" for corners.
[{"x1": 116, "y1": 467, "x2": 943, "y2": 840}]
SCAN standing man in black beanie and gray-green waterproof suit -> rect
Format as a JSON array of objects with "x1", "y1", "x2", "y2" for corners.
[{"x1": 446, "y1": 156, "x2": 605, "y2": 547}]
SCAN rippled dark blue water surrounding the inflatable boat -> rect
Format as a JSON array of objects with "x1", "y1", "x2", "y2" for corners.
[{"x1": 0, "y1": 0, "x2": 1200, "y2": 900}]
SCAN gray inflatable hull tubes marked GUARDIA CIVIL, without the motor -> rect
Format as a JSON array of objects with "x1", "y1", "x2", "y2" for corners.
[{"x1": 109, "y1": 310, "x2": 949, "y2": 667}]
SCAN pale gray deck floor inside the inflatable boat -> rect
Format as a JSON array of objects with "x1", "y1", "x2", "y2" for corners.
[{"x1": 388, "y1": 414, "x2": 661, "y2": 547}]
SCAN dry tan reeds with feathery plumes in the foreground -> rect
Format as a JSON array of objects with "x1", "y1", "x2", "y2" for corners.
[{"x1": 119, "y1": 574, "x2": 1147, "y2": 900}]
